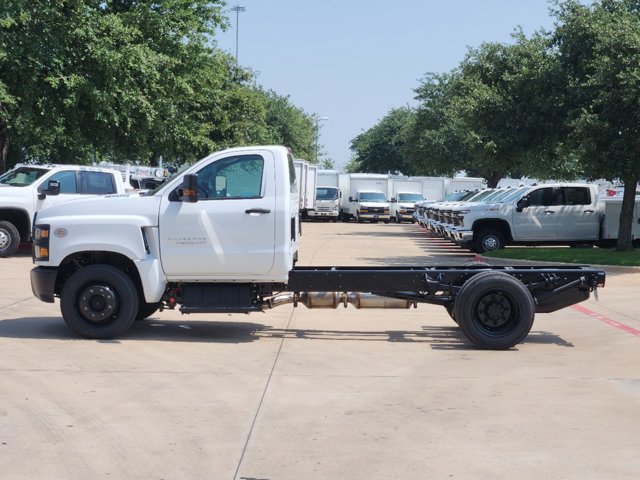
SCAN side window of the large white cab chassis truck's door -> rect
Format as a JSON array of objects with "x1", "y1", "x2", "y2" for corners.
[{"x1": 198, "y1": 155, "x2": 264, "y2": 200}]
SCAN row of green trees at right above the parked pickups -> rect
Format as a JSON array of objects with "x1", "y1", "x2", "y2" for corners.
[{"x1": 352, "y1": 0, "x2": 640, "y2": 249}]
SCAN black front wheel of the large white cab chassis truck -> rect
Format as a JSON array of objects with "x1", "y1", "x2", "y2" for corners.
[{"x1": 60, "y1": 265, "x2": 140, "y2": 339}]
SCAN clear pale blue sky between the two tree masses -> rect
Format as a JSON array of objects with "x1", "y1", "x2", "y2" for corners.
[{"x1": 217, "y1": 0, "x2": 554, "y2": 169}]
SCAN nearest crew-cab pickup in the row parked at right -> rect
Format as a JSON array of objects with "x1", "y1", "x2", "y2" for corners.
[{"x1": 444, "y1": 183, "x2": 624, "y2": 253}]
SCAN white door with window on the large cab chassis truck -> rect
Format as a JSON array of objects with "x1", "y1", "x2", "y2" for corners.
[{"x1": 159, "y1": 151, "x2": 276, "y2": 279}]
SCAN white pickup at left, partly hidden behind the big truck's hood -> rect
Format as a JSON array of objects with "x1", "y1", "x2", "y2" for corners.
[{"x1": 0, "y1": 164, "x2": 126, "y2": 257}]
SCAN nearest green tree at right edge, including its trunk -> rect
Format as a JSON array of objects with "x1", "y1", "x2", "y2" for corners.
[{"x1": 554, "y1": 0, "x2": 640, "y2": 250}]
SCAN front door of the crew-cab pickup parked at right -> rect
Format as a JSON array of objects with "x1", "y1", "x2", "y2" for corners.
[{"x1": 513, "y1": 187, "x2": 559, "y2": 240}]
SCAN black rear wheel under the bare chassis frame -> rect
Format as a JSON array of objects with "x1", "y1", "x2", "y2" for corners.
[{"x1": 453, "y1": 271, "x2": 535, "y2": 350}]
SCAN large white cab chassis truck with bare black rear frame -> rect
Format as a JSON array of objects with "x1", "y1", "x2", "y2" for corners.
[{"x1": 31, "y1": 146, "x2": 605, "y2": 349}]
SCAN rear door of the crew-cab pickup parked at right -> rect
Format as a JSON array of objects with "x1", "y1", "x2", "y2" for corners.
[{"x1": 558, "y1": 186, "x2": 600, "y2": 240}]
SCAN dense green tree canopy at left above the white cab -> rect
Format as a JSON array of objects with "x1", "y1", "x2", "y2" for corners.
[{"x1": 0, "y1": 0, "x2": 313, "y2": 171}]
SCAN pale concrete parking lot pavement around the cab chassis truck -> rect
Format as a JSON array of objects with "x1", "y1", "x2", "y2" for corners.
[{"x1": 0, "y1": 223, "x2": 640, "y2": 480}]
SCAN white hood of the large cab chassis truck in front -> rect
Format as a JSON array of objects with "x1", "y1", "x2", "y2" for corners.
[{"x1": 37, "y1": 194, "x2": 161, "y2": 227}]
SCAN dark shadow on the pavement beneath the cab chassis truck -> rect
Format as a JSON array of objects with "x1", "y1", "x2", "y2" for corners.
[{"x1": 0, "y1": 317, "x2": 573, "y2": 350}]
